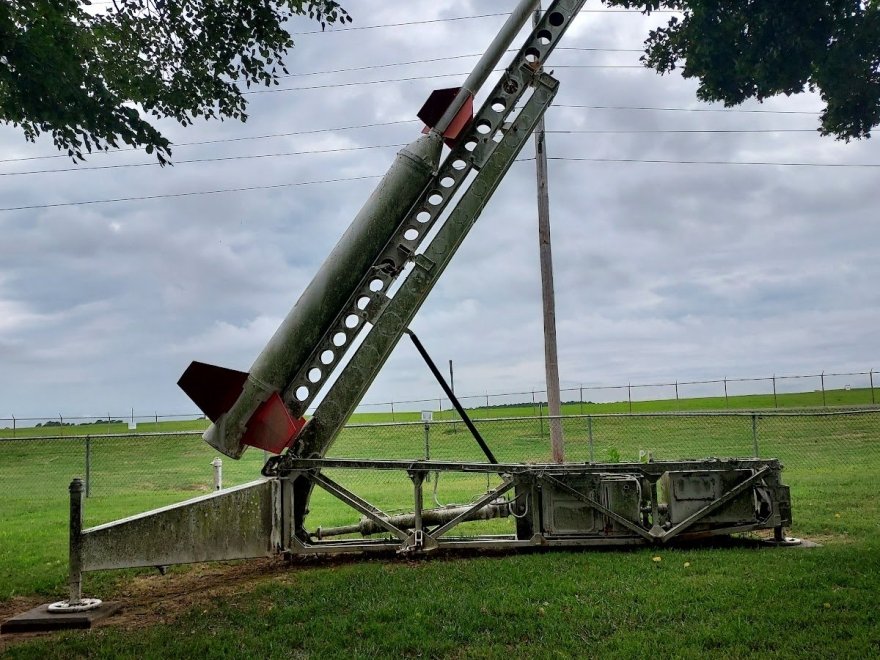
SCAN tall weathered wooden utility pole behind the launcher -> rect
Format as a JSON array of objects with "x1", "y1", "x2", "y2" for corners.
[{"x1": 533, "y1": 2, "x2": 565, "y2": 463}]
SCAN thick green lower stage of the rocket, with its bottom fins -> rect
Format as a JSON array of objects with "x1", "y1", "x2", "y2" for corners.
[{"x1": 186, "y1": 133, "x2": 443, "y2": 458}]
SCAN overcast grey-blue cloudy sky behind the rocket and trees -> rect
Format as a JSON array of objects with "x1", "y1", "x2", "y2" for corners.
[{"x1": 0, "y1": 0, "x2": 880, "y2": 418}]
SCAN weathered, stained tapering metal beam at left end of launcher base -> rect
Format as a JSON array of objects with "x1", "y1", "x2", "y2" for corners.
[{"x1": 80, "y1": 480, "x2": 281, "y2": 571}]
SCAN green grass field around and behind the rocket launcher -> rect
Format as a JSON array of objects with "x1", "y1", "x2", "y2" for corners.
[{"x1": 0, "y1": 392, "x2": 880, "y2": 657}]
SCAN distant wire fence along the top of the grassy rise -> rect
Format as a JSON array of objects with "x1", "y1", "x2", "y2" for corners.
[{"x1": 0, "y1": 369, "x2": 880, "y2": 430}]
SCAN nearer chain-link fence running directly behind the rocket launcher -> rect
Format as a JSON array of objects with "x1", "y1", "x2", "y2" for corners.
[{"x1": 0, "y1": 408, "x2": 880, "y2": 540}]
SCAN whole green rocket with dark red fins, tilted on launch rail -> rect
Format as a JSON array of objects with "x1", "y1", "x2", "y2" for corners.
[{"x1": 178, "y1": 0, "x2": 538, "y2": 458}]
